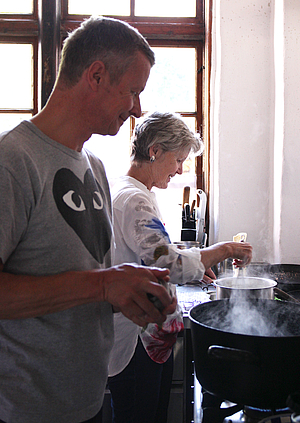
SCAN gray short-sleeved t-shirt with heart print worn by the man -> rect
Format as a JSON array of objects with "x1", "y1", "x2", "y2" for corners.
[{"x1": 0, "y1": 121, "x2": 113, "y2": 423}]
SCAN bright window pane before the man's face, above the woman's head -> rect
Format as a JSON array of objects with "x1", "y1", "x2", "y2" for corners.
[{"x1": 141, "y1": 47, "x2": 196, "y2": 112}]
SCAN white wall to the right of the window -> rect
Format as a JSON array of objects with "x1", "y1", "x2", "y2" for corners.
[{"x1": 210, "y1": 0, "x2": 300, "y2": 263}]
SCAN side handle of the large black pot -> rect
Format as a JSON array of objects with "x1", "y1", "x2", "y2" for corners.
[{"x1": 207, "y1": 345, "x2": 260, "y2": 365}]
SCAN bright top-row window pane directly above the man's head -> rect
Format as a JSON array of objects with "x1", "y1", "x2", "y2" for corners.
[{"x1": 69, "y1": 0, "x2": 130, "y2": 16}]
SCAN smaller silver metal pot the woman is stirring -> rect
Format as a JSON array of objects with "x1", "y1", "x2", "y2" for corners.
[{"x1": 213, "y1": 276, "x2": 277, "y2": 300}]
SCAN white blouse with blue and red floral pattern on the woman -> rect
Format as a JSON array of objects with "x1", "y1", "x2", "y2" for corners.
[{"x1": 109, "y1": 176, "x2": 205, "y2": 376}]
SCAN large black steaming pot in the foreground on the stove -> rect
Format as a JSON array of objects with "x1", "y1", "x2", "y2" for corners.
[{"x1": 189, "y1": 299, "x2": 300, "y2": 409}]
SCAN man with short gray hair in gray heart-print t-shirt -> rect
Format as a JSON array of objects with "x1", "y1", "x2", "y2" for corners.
[{"x1": 0, "y1": 17, "x2": 176, "y2": 423}]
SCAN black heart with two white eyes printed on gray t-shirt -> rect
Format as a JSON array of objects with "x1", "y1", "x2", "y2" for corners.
[{"x1": 53, "y1": 168, "x2": 111, "y2": 263}]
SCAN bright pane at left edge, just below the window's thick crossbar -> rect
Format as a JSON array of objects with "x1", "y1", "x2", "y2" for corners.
[{"x1": 0, "y1": 44, "x2": 33, "y2": 109}]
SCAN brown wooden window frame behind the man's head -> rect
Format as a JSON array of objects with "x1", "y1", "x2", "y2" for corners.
[{"x1": 0, "y1": 0, "x2": 212, "y2": 202}]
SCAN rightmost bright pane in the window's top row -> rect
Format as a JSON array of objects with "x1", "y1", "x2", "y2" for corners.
[{"x1": 135, "y1": 0, "x2": 196, "y2": 18}]
